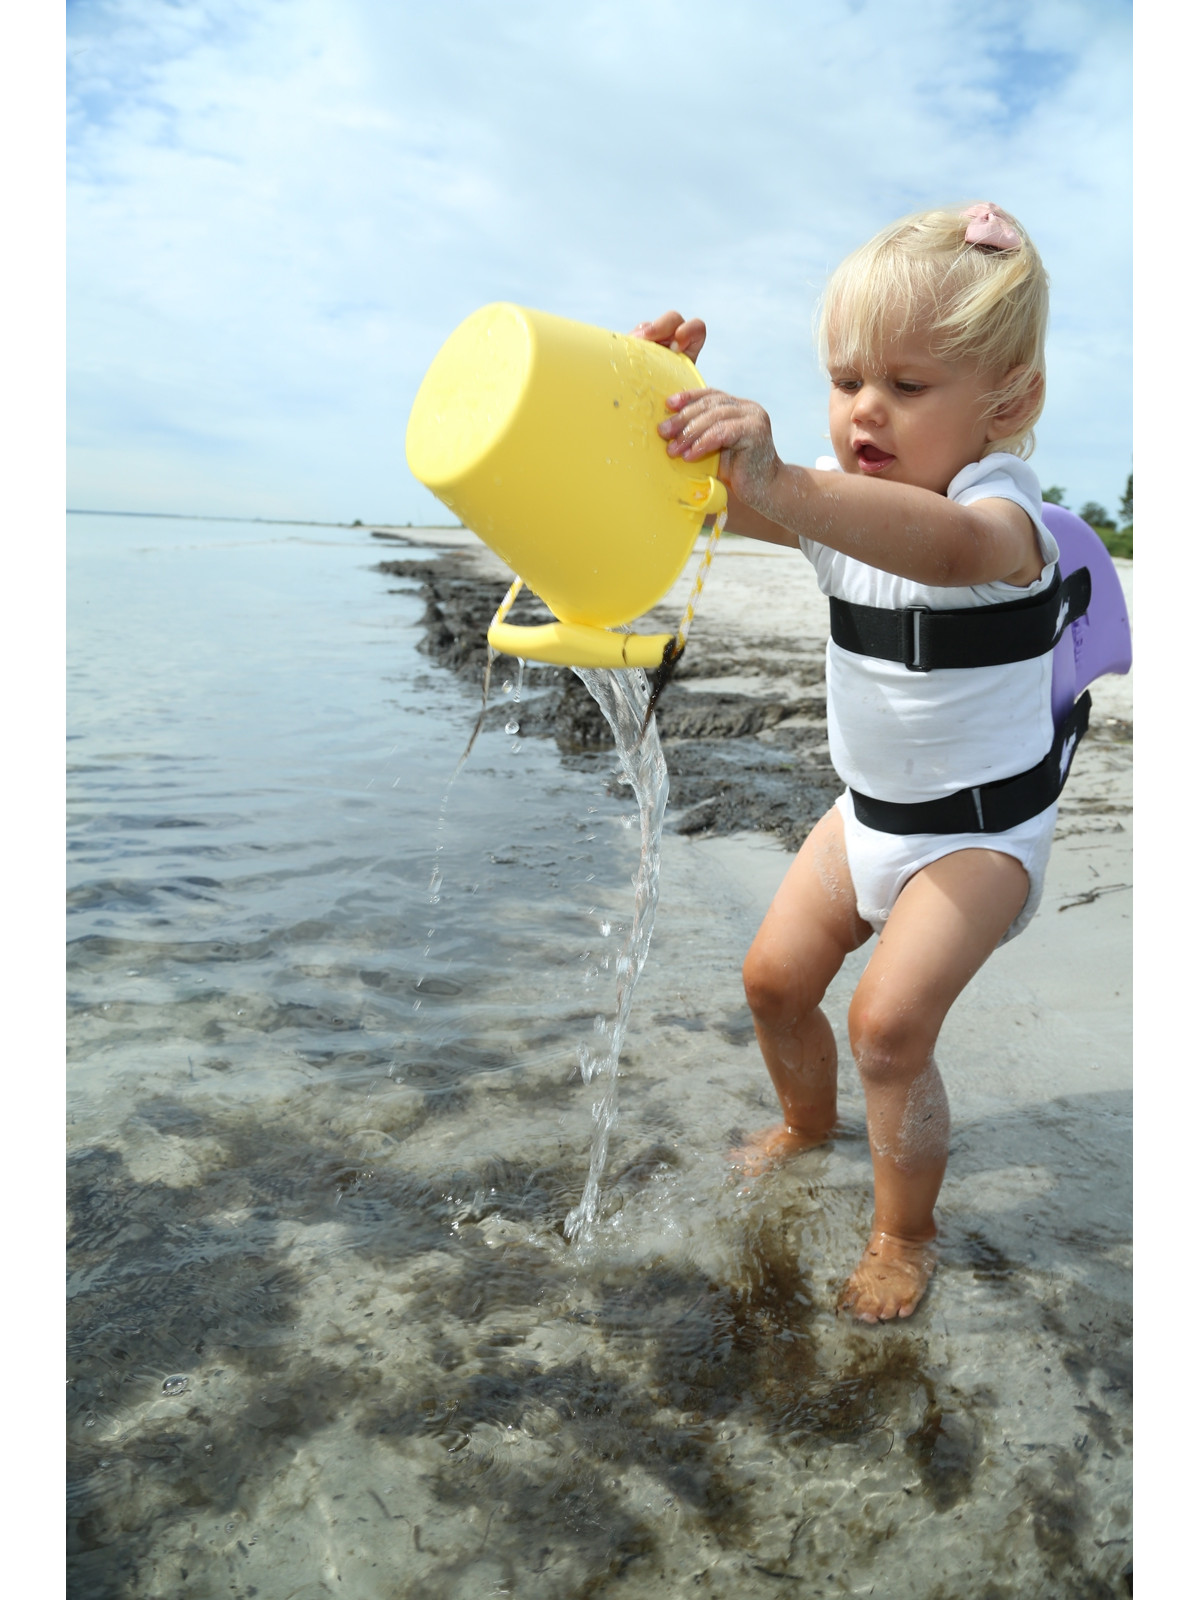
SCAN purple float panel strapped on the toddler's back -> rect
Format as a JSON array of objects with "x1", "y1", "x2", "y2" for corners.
[{"x1": 1042, "y1": 502, "x2": 1133, "y2": 726}]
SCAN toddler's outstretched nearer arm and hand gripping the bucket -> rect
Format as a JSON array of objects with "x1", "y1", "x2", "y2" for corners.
[{"x1": 659, "y1": 389, "x2": 1045, "y2": 587}]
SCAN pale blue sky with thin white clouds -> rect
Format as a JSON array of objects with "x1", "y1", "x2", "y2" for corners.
[{"x1": 66, "y1": 0, "x2": 1133, "y2": 525}]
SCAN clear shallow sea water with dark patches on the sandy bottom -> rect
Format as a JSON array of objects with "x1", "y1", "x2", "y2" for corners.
[{"x1": 67, "y1": 518, "x2": 1128, "y2": 1600}]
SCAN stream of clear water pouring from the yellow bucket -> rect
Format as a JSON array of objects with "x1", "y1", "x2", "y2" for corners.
[{"x1": 565, "y1": 667, "x2": 667, "y2": 1243}]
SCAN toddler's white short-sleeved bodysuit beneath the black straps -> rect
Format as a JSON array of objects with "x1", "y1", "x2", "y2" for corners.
[{"x1": 800, "y1": 451, "x2": 1058, "y2": 942}]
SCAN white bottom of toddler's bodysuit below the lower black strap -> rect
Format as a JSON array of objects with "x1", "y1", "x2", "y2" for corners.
[{"x1": 837, "y1": 790, "x2": 1058, "y2": 944}]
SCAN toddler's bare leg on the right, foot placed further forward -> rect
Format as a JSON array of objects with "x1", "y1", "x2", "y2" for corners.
[{"x1": 838, "y1": 850, "x2": 1029, "y2": 1322}]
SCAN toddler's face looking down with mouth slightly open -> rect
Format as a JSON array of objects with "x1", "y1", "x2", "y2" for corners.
[{"x1": 829, "y1": 326, "x2": 1003, "y2": 494}]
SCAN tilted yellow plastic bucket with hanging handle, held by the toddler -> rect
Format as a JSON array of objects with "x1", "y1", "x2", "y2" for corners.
[{"x1": 405, "y1": 302, "x2": 725, "y2": 667}]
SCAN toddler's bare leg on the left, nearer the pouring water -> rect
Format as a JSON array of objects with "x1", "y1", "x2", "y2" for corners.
[{"x1": 734, "y1": 810, "x2": 870, "y2": 1171}]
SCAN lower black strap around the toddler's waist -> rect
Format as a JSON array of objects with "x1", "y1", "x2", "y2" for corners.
[{"x1": 850, "y1": 691, "x2": 1091, "y2": 834}]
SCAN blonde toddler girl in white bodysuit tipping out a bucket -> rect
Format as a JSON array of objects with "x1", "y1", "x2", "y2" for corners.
[{"x1": 635, "y1": 205, "x2": 1062, "y2": 1322}]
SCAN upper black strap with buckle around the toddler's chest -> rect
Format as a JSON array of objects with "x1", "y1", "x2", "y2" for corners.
[{"x1": 829, "y1": 566, "x2": 1091, "y2": 672}]
